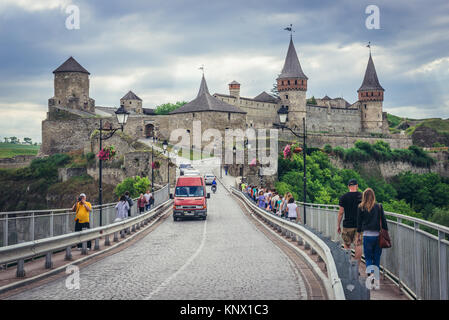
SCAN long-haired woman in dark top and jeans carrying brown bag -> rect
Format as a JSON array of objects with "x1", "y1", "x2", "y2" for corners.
[{"x1": 357, "y1": 188, "x2": 388, "y2": 289}]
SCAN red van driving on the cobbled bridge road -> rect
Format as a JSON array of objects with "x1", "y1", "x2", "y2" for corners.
[{"x1": 170, "y1": 176, "x2": 210, "y2": 221}]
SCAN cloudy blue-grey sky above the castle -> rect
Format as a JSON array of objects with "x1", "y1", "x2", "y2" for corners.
[{"x1": 0, "y1": 0, "x2": 449, "y2": 142}]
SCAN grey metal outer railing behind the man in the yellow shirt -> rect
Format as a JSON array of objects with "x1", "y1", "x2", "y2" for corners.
[{"x1": 0, "y1": 185, "x2": 169, "y2": 247}]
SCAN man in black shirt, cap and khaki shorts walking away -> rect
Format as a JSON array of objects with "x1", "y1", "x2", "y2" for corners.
[{"x1": 337, "y1": 179, "x2": 362, "y2": 264}]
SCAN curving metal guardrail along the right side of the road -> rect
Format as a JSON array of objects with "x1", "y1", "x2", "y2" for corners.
[{"x1": 231, "y1": 187, "x2": 346, "y2": 300}]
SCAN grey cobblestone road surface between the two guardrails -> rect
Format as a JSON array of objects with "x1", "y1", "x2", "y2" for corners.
[{"x1": 9, "y1": 165, "x2": 307, "y2": 300}]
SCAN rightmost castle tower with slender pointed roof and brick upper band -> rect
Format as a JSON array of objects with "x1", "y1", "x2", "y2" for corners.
[{"x1": 357, "y1": 52, "x2": 385, "y2": 133}]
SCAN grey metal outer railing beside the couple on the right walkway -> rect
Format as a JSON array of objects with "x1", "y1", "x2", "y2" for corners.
[{"x1": 297, "y1": 202, "x2": 449, "y2": 300}]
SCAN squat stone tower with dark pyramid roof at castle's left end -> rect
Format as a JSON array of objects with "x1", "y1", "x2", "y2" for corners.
[{"x1": 48, "y1": 57, "x2": 95, "y2": 113}]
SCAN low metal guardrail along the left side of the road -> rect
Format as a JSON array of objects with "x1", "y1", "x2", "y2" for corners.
[{"x1": 0, "y1": 200, "x2": 172, "y2": 277}]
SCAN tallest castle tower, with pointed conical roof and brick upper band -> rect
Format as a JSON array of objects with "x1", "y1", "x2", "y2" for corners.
[{"x1": 276, "y1": 36, "x2": 308, "y2": 127}]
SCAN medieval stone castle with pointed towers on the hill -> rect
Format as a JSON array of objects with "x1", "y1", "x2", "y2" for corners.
[{"x1": 41, "y1": 36, "x2": 412, "y2": 154}]
